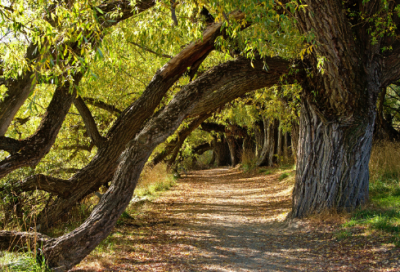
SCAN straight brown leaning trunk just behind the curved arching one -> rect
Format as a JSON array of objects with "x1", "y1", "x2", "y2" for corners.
[{"x1": 33, "y1": 21, "x2": 225, "y2": 228}]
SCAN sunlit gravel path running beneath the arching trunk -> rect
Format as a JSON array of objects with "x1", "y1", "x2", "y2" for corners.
[{"x1": 148, "y1": 169, "x2": 313, "y2": 271}]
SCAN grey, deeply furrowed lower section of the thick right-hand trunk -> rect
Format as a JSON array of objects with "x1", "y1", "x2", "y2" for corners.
[{"x1": 292, "y1": 101, "x2": 375, "y2": 217}]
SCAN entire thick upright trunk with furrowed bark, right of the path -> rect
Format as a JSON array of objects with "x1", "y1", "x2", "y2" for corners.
[{"x1": 292, "y1": 0, "x2": 400, "y2": 217}]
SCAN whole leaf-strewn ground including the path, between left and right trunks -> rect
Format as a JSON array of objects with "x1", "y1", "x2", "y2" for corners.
[{"x1": 71, "y1": 168, "x2": 400, "y2": 272}]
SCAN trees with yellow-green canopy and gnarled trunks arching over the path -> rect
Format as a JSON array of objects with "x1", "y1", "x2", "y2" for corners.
[{"x1": 0, "y1": 0, "x2": 400, "y2": 271}]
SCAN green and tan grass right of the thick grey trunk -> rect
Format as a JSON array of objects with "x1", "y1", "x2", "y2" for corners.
[{"x1": 342, "y1": 142, "x2": 400, "y2": 247}]
